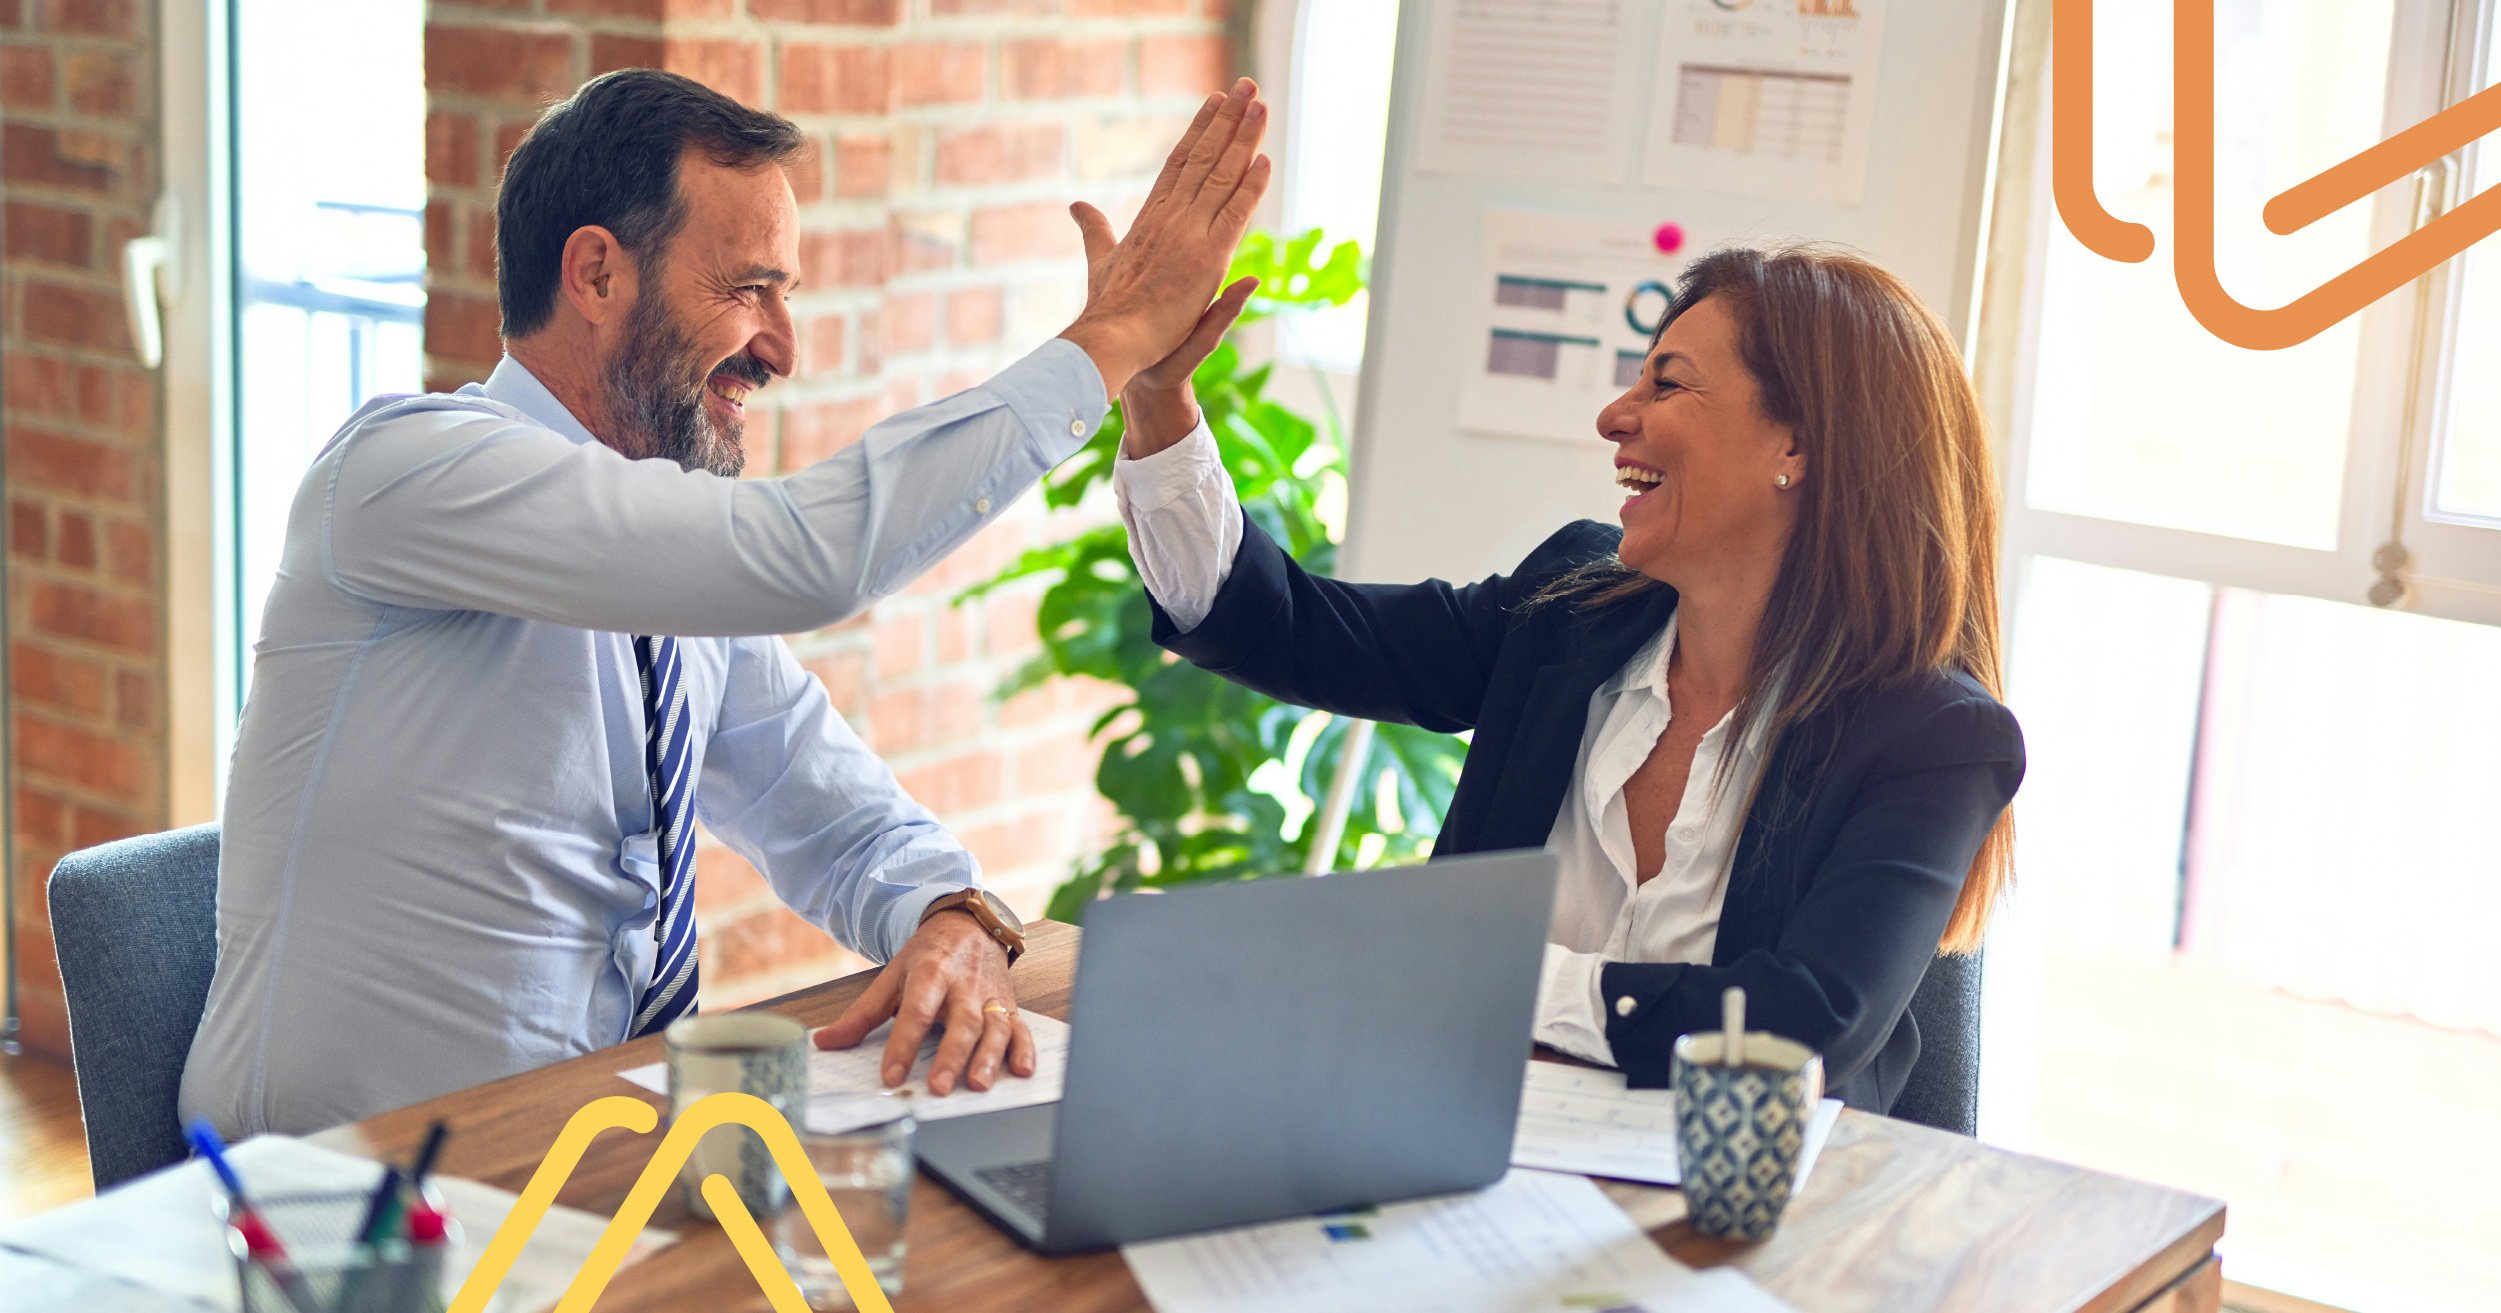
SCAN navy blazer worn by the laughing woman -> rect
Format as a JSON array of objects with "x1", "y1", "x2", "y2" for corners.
[{"x1": 1155, "y1": 518, "x2": 2023, "y2": 1113}]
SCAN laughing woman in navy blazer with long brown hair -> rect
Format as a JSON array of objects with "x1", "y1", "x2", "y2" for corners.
[{"x1": 1115, "y1": 248, "x2": 2023, "y2": 1113}]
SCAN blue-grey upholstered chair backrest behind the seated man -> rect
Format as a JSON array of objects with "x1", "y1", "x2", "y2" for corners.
[{"x1": 50, "y1": 825, "x2": 218, "y2": 1190}]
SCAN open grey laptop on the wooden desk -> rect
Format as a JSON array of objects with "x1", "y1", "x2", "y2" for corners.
[{"x1": 915, "y1": 850, "x2": 1556, "y2": 1253}]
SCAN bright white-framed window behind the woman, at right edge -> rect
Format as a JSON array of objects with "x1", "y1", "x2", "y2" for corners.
[{"x1": 1983, "y1": 0, "x2": 2501, "y2": 1310}]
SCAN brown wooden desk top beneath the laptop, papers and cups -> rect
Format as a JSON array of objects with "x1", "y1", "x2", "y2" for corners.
[{"x1": 315, "y1": 923, "x2": 2223, "y2": 1313}]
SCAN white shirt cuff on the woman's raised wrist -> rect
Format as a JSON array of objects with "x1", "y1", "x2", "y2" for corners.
[{"x1": 1110, "y1": 413, "x2": 1243, "y2": 633}]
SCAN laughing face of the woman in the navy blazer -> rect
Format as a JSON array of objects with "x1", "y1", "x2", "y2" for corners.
[{"x1": 1598, "y1": 298, "x2": 1806, "y2": 588}]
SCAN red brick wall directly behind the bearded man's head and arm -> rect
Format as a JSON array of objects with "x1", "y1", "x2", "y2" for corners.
[{"x1": 425, "y1": 0, "x2": 1233, "y2": 1005}]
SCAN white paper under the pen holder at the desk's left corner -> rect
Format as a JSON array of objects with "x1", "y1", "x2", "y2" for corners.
[{"x1": 0, "y1": 1135, "x2": 678, "y2": 1313}]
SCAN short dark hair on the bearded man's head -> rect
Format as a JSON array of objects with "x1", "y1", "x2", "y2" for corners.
[{"x1": 495, "y1": 68, "x2": 808, "y2": 338}]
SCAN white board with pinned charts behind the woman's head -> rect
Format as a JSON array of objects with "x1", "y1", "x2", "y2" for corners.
[{"x1": 1341, "y1": 0, "x2": 2008, "y2": 583}]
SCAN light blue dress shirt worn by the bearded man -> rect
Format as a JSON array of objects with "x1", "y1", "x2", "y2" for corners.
[{"x1": 183, "y1": 340, "x2": 1108, "y2": 1138}]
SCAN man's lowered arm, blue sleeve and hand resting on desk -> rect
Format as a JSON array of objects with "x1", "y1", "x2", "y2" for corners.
[{"x1": 695, "y1": 638, "x2": 1033, "y2": 1095}]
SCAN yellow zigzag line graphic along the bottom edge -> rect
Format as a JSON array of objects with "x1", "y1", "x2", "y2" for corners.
[{"x1": 450, "y1": 1093, "x2": 895, "y2": 1313}]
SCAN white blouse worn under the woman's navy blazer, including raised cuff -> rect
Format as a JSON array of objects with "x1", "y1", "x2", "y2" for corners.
[{"x1": 1113, "y1": 420, "x2": 1763, "y2": 1065}]
